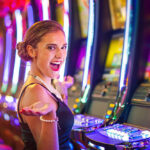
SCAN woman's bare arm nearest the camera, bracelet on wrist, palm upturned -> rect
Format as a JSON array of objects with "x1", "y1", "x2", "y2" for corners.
[{"x1": 21, "y1": 85, "x2": 59, "y2": 150}]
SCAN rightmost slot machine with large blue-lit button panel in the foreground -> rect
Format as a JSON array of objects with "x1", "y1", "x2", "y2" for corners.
[{"x1": 85, "y1": 0, "x2": 150, "y2": 150}]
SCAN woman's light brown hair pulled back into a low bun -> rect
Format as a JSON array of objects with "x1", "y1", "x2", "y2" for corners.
[{"x1": 16, "y1": 20, "x2": 65, "y2": 61}]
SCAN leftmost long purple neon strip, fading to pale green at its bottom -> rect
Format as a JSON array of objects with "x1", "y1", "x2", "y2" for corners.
[{"x1": 1, "y1": 28, "x2": 12, "y2": 92}]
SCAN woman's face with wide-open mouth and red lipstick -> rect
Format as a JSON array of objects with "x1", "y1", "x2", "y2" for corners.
[{"x1": 35, "y1": 31, "x2": 67, "y2": 78}]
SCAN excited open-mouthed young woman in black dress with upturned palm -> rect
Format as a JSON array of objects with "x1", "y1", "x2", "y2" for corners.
[{"x1": 17, "y1": 20, "x2": 74, "y2": 150}]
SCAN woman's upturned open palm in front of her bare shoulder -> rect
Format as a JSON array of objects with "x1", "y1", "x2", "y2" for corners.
[{"x1": 19, "y1": 101, "x2": 52, "y2": 116}]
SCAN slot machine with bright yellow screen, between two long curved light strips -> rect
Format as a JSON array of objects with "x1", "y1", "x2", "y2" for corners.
[{"x1": 72, "y1": 0, "x2": 127, "y2": 146}]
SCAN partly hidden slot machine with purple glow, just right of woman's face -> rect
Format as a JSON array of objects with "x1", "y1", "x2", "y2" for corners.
[{"x1": 67, "y1": 0, "x2": 89, "y2": 110}]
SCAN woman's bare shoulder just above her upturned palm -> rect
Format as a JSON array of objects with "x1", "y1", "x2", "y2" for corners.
[{"x1": 22, "y1": 84, "x2": 56, "y2": 107}]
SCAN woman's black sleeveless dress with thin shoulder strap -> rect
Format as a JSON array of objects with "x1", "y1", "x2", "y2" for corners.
[{"x1": 17, "y1": 83, "x2": 74, "y2": 150}]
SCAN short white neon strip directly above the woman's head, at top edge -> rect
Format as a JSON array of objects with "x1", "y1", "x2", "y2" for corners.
[{"x1": 42, "y1": 0, "x2": 49, "y2": 20}]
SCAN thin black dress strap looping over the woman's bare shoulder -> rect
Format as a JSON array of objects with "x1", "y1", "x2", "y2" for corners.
[{"x1": 17, "y1": 82, "x2": 61, "y2": 123}]
